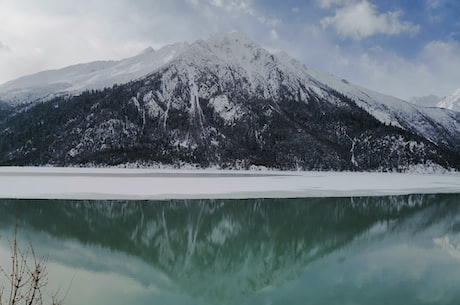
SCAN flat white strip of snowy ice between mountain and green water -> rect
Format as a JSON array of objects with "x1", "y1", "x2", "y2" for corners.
[{"x1": 0, "y1": 167, "x2": 460, "y2": 199}]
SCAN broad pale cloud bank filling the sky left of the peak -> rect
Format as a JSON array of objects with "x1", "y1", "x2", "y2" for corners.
[{"x1": 0, "y1": 0, "x2": 280, "y2": 83}]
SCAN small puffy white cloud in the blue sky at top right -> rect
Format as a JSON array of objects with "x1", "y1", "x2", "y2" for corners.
[{"x1": 321, "y1": 0, "x2": 419, "y2": 40}]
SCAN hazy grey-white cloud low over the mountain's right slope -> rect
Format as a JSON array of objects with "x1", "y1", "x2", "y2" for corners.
[{"x1": 336, "y1": 41, "x2": 460, "y2": 100}]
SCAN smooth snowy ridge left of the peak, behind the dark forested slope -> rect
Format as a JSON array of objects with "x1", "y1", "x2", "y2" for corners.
[{"x1": 0, "y1": 43, "x2": 187, "y2": 104}]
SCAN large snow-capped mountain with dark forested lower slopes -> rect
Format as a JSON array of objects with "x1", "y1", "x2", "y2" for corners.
[{"x1": 0, "y1": 32, "x2": 460, "y2": 170}]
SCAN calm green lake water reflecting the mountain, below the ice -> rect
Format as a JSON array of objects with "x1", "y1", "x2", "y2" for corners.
[{"x1": 0, "y1": 195, "x2": 460, "y2": 305}]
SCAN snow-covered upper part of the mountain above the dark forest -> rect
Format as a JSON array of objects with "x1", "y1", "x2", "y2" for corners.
[{"x1": 0, "y1": 32, "x2": 460, "y2": 133}]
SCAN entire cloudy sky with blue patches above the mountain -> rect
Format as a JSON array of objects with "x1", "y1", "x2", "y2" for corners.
[{"x1": 0, "y1": 0, "x2": 460, "y2": 99}]
